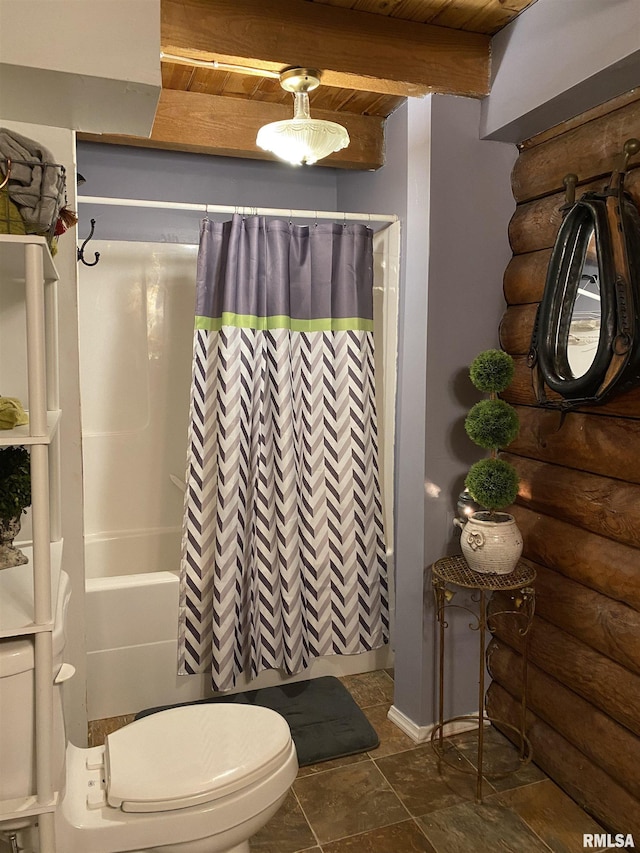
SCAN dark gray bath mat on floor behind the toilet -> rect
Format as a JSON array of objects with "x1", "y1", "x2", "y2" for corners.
[{"x1": 136, "y1": 675, "x2": 380, "y2": 767}]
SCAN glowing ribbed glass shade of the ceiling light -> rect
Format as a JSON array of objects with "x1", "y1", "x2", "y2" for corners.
[{"x1": 256, "y1": 118, "x2": 350, "y2": 166}]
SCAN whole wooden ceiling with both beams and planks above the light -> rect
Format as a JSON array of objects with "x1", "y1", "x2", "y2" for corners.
[{"x1": 78, "y1": 0, "x2": 535, "y2": 169}]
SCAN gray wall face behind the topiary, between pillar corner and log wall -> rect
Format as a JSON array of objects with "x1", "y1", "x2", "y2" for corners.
[{"x1": 421, "y1": 96, "x2": 518, "y2": 721}]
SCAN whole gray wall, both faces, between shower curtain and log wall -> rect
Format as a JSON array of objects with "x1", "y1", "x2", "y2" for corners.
[{"x1": 338, "y1": 96, "x2": 517, "y2": 736}]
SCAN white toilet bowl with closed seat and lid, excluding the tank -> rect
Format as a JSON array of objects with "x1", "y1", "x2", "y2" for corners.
[{"x1": 56, "y1": 703, "x2": 298, "y2": 853}]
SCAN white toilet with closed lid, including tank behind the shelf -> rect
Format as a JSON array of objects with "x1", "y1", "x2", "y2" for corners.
[{"x1": 0, "y1": 572, "x2": 298, "y2": 853}]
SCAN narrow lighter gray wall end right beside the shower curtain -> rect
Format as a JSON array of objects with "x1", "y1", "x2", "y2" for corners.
[{"x1": 338, "y1": 99, "x2": 431, "y2": 726}]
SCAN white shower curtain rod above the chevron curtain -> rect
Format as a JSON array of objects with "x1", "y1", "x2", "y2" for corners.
[{"x1": 77, "y1": 195, "x2": 398, "y2": 222}]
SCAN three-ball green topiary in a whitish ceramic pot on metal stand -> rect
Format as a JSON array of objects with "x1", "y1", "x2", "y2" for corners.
[{"x1": 460, "y1": 349, "x2": 522, "y2": 574}]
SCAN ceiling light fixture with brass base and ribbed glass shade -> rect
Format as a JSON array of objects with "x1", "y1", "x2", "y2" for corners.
[{"x1": 256, "y1": 68, "x2": 350, "y2": 166}]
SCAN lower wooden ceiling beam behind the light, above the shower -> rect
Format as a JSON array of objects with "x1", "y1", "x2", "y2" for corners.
[{"x1": 78, "y1": 89, "x2": 384, "y2": 170}]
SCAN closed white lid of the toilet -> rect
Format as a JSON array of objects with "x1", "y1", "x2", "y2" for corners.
[{"x1": 105, "y1": 703, "x2": 291, "y2": 812}]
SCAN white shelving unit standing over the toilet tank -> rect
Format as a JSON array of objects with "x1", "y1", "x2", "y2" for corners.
[{"x1": 0, "y1": 234, "x2": 63, "y2": 853}]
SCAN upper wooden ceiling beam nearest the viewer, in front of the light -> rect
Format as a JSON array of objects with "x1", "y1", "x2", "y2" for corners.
[{"x1": 161, "y1": 0, "x2": 490, "y2": 97}]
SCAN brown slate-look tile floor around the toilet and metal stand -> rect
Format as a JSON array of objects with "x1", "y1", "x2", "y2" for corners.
[{"x1": 90, "y1": 671, "x2": 603, "y2": 853}]
